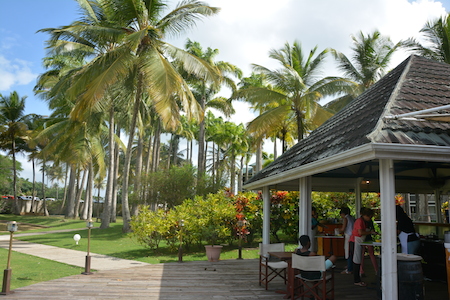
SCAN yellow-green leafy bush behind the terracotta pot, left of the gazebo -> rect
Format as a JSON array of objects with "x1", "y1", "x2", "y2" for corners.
[{"x1": 130, "y1": 192, "x2": 241, "y2": 249}]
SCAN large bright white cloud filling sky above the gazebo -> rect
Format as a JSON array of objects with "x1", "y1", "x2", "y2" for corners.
[{"x1": 168, "y1": 0, "x2": 446, "y2": 75}]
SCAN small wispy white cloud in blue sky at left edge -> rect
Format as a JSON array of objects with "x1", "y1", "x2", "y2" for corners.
[{"x1": 0, "y1": 55, "x2": 38, "y2": 92}]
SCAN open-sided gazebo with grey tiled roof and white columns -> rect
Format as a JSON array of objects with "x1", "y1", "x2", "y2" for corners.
[{"x1": 244, "y1": 55, "x2": 450, "y2": 299}]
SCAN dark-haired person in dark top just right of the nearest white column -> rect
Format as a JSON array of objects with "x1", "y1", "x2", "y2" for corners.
[{"x1": 395, "y1": 205, "x2": 420, "y2": 255}]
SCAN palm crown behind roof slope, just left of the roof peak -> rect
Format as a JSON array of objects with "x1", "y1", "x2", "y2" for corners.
[{"x1": 325, "y1": 30, "x2": 402, "y2": 112}]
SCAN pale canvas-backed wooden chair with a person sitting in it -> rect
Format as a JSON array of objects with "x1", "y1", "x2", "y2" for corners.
[{"x1": 290, "y1": 254, "x2": 334, "y2": 300}]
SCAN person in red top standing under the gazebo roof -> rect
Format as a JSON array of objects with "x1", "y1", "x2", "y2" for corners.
[{"x1": 350, "y1": 208, "x2": 376, "y2": 286}]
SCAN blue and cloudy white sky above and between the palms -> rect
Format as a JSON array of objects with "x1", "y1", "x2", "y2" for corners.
[{"x1": 0, "y1": 0, "x2": 450, "y2": 183}]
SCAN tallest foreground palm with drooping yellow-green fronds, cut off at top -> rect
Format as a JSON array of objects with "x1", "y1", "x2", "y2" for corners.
[{"x1": 40, "y1": 0, "x2": 218, "y2": 232}]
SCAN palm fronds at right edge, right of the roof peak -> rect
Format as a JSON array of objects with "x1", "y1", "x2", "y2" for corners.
[{"x1": 403, "y1": 14, "x2": 450, "y2": 64}]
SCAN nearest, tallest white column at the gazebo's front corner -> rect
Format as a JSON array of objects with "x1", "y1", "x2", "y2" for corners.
[{"x1": 380, "y1": 159, "x2": 398, "y2": 300}]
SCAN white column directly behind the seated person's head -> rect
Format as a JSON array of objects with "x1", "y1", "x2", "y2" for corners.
[{"x1": 298, "y1": 176, "x2": 312, "y2": 237}]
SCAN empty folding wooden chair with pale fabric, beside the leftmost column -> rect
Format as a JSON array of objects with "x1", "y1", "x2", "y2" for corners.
[{"x1": 259, "y1": 243, "x2": 288, "y2": 290}]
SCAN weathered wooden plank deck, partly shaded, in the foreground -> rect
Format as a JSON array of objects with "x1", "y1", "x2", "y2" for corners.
[{"x1": 3, "y1": 260, "x2": 447, "y2": 300}]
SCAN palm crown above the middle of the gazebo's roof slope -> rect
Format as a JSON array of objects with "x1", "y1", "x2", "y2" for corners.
[{"x1": 237, "y1": 41, "x2": 351, "y2": 143}]
